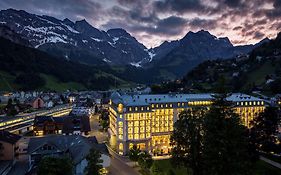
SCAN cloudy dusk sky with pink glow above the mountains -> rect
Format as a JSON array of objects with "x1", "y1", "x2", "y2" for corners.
[{"x1": 0, "y1": 0, "x2": 281, "y2": 47}]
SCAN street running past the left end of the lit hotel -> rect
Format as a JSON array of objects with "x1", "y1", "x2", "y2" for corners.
[{"x1": 89, "y1": 115, "x2": 140, "y2": 175}]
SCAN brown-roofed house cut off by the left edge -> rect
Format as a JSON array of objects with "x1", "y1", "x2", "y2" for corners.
[{"x1": 0, "y1": 130, "x2": 21, "y2": 160}]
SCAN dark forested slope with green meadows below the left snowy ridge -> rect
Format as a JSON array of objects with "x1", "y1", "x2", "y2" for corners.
[{"x1": 0, "y1": 34, "x2": 127, "y2": 91}]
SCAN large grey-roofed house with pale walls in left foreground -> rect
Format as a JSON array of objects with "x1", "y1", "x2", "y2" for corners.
[{"x1": 28, "y1": 135, "x2": 110, "y2": 175}]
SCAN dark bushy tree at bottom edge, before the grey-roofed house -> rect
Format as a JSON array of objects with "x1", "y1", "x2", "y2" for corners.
[{"x1": 38, "y1": 157, "x2": 73, "y2": 175}]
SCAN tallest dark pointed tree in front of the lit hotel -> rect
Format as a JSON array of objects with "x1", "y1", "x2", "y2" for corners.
[{"x1": 202, "y1": 95, "x2": 252, "y2": 175}]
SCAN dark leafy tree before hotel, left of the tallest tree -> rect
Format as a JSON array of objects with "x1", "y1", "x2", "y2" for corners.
[{"x1": 171, "y1": 108, "x2": 205, "y2": 175}]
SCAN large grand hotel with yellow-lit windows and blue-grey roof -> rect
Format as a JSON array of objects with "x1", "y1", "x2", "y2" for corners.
[{"x1": 108, "y1": 93, "x2": 265, "y2": 155}]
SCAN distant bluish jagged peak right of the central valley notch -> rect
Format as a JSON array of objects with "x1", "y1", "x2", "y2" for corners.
[{"x1": 148, "y1": 30, "x2": 267, "y2": 78}]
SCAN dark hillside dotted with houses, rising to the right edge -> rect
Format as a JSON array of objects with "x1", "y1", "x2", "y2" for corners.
[{"x1": 153, "y1": 33, "x2": 281, "y2": 95}]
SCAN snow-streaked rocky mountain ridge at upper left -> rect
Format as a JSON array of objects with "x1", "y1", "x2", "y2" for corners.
[{"x1": 0, "y1": 9, "x2": 150, "y2": 65}]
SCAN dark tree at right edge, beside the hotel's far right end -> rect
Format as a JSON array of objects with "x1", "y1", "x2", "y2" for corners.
[{"x1": 250, "y1": 107, "x2": 281, "y2": 153}]
